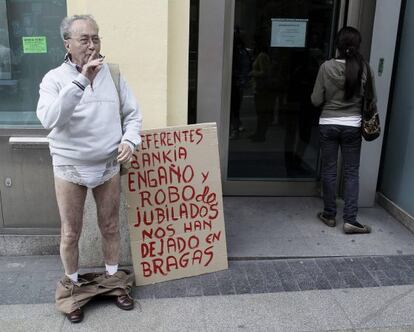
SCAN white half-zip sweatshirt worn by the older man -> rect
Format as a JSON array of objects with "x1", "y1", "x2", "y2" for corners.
[{"x1": 36, "y1": 61, "x2": 142, "y2": 166}]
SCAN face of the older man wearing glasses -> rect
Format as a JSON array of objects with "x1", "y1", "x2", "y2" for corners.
[{"x1": 64, "y1": 20, "x2": 101, "y2": 67}]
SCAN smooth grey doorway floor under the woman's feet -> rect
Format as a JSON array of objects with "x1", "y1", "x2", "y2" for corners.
[{"x1": 224, "y1": 197, "x2": 414, "y2": 258}]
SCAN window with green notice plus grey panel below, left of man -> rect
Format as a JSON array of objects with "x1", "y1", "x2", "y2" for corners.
[{"x1": 0, "y1": 0, "x2": 67, "y2": 235}]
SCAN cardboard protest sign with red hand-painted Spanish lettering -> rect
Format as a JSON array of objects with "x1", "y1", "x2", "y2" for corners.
[{"x1": 123, "y1": 124, "x2": 228, "y2": 285}]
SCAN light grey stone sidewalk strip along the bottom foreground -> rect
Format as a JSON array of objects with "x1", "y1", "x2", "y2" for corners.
[{"x1": 0, "y1": 286, "x2": 414, "y2": 332}]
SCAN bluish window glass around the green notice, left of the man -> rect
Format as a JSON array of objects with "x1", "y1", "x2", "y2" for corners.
[{"x1": 0, "y1": 0, "x2": 66, "y2": 127}]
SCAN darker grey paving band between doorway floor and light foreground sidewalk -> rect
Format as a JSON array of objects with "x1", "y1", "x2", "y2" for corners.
[{"x1": 0, "y1": 255, "x2": 414, "y2": 305}]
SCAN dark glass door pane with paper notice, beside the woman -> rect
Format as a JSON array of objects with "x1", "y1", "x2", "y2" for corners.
[{"x1": 223, "y1": 0, "x2": 340, "y2": 196}]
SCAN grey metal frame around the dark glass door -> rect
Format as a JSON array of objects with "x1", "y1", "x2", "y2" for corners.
[{"x1": 197, "y1": 0, "x2": 360, "y2": 196}]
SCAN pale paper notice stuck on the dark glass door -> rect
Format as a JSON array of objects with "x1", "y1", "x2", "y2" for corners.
[{"x1": 270, "y1": 18, "x2": 308, "y2": 47}]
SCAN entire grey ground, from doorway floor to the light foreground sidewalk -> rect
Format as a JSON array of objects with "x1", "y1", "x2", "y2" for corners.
[{"x1": 0, "y1": 197, "x2": 414, "y2": 332}]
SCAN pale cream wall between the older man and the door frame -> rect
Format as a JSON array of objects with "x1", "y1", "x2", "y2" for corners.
[{"x1": 67, "y1": 0, "x2": 189, "y2": 129}]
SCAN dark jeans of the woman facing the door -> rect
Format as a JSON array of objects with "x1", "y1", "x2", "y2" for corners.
[{"x1": 319, "y1": 125, "x2": 361, "y2": 223}]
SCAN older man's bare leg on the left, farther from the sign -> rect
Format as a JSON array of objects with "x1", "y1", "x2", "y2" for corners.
[{"x1": 55, "y1": 177, "x2": 87, "y2": 275}]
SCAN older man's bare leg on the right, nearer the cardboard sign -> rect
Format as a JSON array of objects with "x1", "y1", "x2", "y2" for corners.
[{"x1": 93, "y1": 173, "x2": 121, "y2": 265}]
